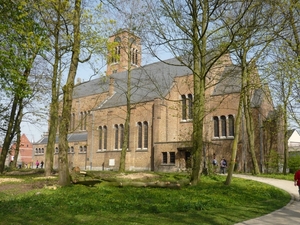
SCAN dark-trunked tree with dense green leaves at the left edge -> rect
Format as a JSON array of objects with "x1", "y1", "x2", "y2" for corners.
[{"x1": 0, "y1": 1, "x2": 46, "y2": 173}]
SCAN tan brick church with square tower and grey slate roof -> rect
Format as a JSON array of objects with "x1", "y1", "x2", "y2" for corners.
[{"x1": 33, "y1": 31, "x2": 274, "y2": 172}]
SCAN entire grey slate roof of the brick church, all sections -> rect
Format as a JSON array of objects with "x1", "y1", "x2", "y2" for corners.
[{"x1": 73, "y1": 58, "x2": 270, "y2": 109}]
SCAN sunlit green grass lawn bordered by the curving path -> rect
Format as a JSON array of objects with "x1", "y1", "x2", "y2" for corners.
[{"x1": 0, "y1": 176, "x2": 290, "y2": 225}]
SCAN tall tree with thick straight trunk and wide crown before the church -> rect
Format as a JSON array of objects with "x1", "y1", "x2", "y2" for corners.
[{"x1": 145, "y1": 0, "x2": 252, "y2": 185}]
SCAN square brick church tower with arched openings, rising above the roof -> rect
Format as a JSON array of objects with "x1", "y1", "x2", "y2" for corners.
[{"x1": 106, "y1": 30, "x2": 141, "y2": 76}]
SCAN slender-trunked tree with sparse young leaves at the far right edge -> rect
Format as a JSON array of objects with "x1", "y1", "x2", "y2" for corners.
[{"x1": 268, "y1": 0, "x2": 300, "y2": 174}]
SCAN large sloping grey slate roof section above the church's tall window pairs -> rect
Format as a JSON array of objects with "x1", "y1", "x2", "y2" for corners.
[{"x1": 100, "y1": 59, "x2": 192, "y2": 109}]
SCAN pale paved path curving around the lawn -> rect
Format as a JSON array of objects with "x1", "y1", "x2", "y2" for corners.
[{"x1": 233, "y1": 174, "x2": 300, "y2": 225}]
